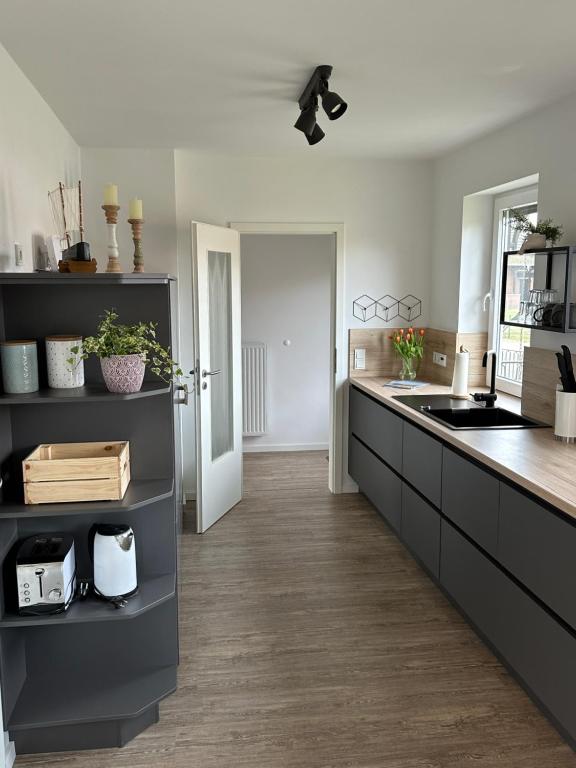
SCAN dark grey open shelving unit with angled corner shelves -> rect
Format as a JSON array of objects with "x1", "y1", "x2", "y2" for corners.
[{"x1": 0, "y1": 274, "x2": 178, "y2": 753}]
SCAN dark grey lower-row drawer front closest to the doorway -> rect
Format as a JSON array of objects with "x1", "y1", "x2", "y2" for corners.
[{"x1": 348, "y1": 435, "x2": 402, "y2": 531}]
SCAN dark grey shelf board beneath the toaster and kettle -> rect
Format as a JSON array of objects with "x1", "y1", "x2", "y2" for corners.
[{"x1": 0, "y1": 573, "x2": 176, "y2": 630}]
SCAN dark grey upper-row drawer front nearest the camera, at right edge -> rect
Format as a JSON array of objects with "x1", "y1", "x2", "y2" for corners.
[{"x1": 498, "y1": 483, "x2": 576, "y2": 628}]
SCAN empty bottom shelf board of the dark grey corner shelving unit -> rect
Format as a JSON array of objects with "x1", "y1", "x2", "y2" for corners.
[{"x1": 8, "y1": 659, "x2": 176, "y2": 731}]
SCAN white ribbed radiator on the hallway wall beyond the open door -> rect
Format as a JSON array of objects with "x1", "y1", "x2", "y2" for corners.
[{"x1": 242, "y1": 341, "x2": 266, "y2": 437}]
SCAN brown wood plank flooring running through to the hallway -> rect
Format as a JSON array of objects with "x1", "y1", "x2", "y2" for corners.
[{"x1": 16, "y1": 453, "x2": 576, "y2": 768}]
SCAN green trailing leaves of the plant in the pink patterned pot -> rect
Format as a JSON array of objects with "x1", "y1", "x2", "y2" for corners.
[{"x1": 68, "y1": 309, "x2": 184, "y2": 384}]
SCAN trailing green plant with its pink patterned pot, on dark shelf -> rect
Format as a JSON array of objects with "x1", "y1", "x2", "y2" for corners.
[{"x1": 79, "y1": 310, "x2": 183, "y2": 394}]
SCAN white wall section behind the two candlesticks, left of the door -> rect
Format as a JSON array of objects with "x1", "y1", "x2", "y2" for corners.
[{"x1": 82, "y1": 147, "x2": 177, "y2": 275}]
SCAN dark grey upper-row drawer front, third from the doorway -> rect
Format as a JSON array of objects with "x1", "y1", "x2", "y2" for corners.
[{"x1": 442, "y1": 448, "x2": 500, "y2": 555}]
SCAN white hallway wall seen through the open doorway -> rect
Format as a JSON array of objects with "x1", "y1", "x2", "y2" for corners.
[{"x1": 241, "y1": 234, "x2": 336, "y2": 451}]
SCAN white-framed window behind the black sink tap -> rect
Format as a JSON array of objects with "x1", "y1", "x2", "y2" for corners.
[{"x1": 488, "y1": 187, "x2": 538, "y2": 396}]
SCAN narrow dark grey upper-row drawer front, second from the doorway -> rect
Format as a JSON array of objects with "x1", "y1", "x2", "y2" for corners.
[{"x1": 402, "y1": 422, "x2": 442, "y2": 507}]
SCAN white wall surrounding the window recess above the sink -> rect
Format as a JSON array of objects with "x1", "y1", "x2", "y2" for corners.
[{"x1": 430, "y1": 88, "x2": 576, "y2": 346}]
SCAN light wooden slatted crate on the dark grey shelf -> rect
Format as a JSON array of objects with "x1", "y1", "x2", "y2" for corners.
[{"x1": 22, "y1": 441, "x2": 130, "y2": 504}]
